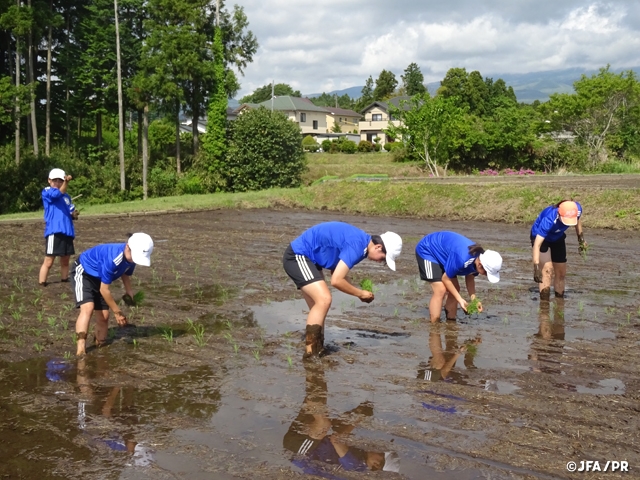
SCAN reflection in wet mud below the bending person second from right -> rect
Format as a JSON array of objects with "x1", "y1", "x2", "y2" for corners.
[{"x1": 418, "y1": 321, "x2": 482, "y2": 385}]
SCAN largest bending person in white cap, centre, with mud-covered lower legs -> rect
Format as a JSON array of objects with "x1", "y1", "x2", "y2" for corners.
[{"x1": 282, "y1": 222, "x2": 402, "y2": 358}]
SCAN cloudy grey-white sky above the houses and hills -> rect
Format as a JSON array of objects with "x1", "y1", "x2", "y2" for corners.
[{"x1": 234, "y1": 0, "x2": 640, "y2": 98}]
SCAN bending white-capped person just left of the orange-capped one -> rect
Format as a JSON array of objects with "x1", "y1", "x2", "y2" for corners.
[{"x1": 416, "y1": 232, "x2": 502, "y2": 323}]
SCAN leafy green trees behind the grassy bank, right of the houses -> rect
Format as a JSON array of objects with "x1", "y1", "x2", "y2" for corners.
[{"x1": 388, "y1": 67, "x2": 640, "y2": 176}]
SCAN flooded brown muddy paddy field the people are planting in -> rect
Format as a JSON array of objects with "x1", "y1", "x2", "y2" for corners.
[{"x1": 0, "y1": 211, "x2": 640, "y2": 479}]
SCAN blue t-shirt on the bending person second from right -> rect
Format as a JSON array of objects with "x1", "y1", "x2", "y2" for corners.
[{"x1": 416, "y1": 232, "x2": 478, "y2": 278}]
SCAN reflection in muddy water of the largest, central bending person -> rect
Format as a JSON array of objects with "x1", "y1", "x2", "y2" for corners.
[{"x1": 282, "y1": 363, "x2": 400, "y2": 479}]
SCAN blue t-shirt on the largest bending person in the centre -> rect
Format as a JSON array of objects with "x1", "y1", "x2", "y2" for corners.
[{"x1": 291, "y1": 222, "x2": 371, "y2": 270}]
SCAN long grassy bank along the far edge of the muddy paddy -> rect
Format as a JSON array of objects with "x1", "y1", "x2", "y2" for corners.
[{"x1": 5, "y1": 181, "x2": 640, "y2": 230}]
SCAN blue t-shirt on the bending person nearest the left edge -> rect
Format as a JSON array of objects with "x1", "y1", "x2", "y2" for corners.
[{"x1": 78, "y1": 243, "x2": 136, "y2": 285}]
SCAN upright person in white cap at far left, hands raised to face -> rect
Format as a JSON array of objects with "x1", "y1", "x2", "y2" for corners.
[{"x1": 38, "y1": 168, "x2": 78, "y2": 287}]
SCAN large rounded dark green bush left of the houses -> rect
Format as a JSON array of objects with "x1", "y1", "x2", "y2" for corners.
[{"x1": 219, "y1": 107, "x2": 305, "y2": 191}]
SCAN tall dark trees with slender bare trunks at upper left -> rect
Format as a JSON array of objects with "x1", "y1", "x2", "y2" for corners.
[{"x1": 0, "y1": 0, "x2": 258, "y2": 203}]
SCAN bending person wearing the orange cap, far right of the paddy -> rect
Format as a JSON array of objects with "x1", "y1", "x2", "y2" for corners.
[{"x1": 530, "y1": 200, "x2": 587, "y2": 300}]
